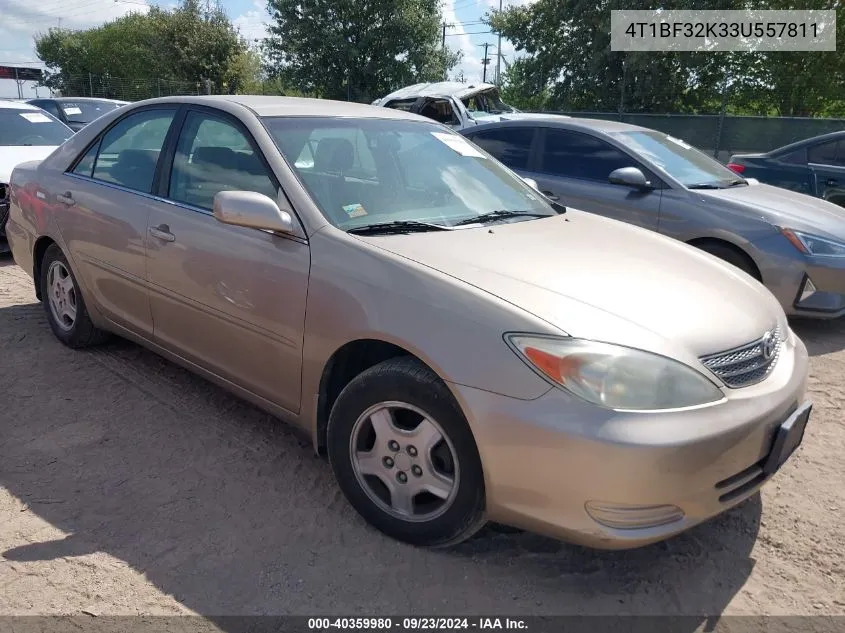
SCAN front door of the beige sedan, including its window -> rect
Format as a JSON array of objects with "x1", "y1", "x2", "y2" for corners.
[{"x1": 147, "y1": 110, "x2": 310, "y2": 413}]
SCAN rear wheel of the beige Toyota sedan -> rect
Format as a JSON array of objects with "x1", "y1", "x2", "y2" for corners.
[{"x1": 41, "y1": 244, "x2": 109, "y2": 349}]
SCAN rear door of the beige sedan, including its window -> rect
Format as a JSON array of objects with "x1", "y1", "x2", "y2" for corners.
[{"x1": 59, "y1": 107, "x2": 176, "y2": 335}]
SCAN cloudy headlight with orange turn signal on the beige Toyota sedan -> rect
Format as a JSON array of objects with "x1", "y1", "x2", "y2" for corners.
[{"x1": 505, "y1": 334, "x2": 725, "y2": 411}]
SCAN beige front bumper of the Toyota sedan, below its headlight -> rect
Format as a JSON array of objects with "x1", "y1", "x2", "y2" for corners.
[{"x1": 453, "y1": 333, "x2": 808, "y2": 549}]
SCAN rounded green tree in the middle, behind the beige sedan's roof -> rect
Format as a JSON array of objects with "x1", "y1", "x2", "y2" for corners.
[{"x1": 265, "y1": 0, "x2": 459, "y2": 102}]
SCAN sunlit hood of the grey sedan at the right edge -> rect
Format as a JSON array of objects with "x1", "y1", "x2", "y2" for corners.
[{"x1": 694, "y1": 184, "x2": 845, "y2": 240}]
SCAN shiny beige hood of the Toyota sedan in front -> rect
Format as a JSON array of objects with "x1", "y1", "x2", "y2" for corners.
[{"x1": 361, "y1": 209, "x2": 786, "y2": 364}]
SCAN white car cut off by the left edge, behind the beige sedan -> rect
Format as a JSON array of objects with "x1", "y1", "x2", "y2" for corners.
[{"x1": 0, "y1": 100, "x2": 73, "y2": 253}]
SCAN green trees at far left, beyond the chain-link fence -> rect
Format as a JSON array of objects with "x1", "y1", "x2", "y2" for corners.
[{"x1": 35, "y1": 0, "x2": 252, "y2": 99}]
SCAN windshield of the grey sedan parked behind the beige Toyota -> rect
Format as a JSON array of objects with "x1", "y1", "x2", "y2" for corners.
[{"x1": 613, "y1": 130, "x2": 737, "y2": 187}]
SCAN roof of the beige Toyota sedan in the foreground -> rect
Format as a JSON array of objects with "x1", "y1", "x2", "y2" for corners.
[{"x1": 123, "y1": 95, "x2": 431, "y2": 123}]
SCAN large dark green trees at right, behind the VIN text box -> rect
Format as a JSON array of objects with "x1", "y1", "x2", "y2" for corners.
[{"x1": 487, "y1": 0, "x2": 845, "y2": 116}]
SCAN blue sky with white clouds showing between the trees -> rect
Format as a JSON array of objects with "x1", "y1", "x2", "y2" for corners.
[{"x1": 0, "y1": 0, "x2": 534, "y2": 99}]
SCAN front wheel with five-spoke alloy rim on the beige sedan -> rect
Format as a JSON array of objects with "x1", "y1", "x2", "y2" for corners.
[{"x1": 328, "y1": 357, "x2": 485, "y2": 547}]
